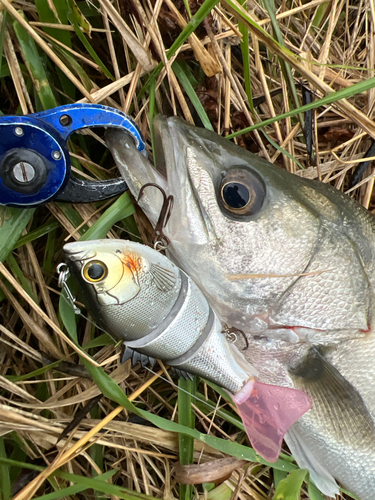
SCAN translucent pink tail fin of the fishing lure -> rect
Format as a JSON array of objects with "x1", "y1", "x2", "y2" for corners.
[{"x1": 233, "y1": 379, "x2": 311, "y2": 462}]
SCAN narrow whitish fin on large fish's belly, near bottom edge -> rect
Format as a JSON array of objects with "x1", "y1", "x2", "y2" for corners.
[{"x1": 285, "y1": 426, "x2": 340, "y2": 498}]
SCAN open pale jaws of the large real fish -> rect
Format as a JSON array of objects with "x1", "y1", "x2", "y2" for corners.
[{"x1": 106, "y1": 115, "x2": 216, "y2": 244}]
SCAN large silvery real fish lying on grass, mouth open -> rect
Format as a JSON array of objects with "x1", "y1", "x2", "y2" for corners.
[{"x1": 106, "y1": 116, "x2": 375, "y2": 500}]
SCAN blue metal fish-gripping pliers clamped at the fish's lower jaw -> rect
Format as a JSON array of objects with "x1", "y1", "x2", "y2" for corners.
[{"x1": 0, "y1": 104, "x2": 146, "y2": 208}]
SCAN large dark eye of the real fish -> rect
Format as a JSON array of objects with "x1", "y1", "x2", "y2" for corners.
[{"x1": 218, "y1": 168, "x2": 265, "y2": 216}]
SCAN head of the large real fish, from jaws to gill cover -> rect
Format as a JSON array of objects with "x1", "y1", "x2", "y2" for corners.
[{"x1": 107, "y1": 116, "x2": 373, "y2": 335}]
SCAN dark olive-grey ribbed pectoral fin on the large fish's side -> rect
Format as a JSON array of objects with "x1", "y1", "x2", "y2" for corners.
[{"x1": 288, "y1": 346, "x2": 375, "y2": 446}]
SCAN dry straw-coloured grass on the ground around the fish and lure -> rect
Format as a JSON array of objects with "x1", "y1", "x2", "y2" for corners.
[{"x1": 0, "y1": 0, "x2": 375, "y2": 500}]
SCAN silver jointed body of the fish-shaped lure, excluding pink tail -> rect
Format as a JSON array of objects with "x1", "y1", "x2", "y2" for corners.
[{"x1": 64, "y1": 240, "x2": 257, "y2": 394}]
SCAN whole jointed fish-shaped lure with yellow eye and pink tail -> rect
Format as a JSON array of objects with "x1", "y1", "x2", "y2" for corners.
[{"x1": 60, "y1": 239, "x2": 311, "y2": 462}]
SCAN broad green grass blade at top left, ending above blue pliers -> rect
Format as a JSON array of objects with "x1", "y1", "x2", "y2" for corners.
[{"x1": 13, "y1": 12, "x2": 58, "y2": 109}]
